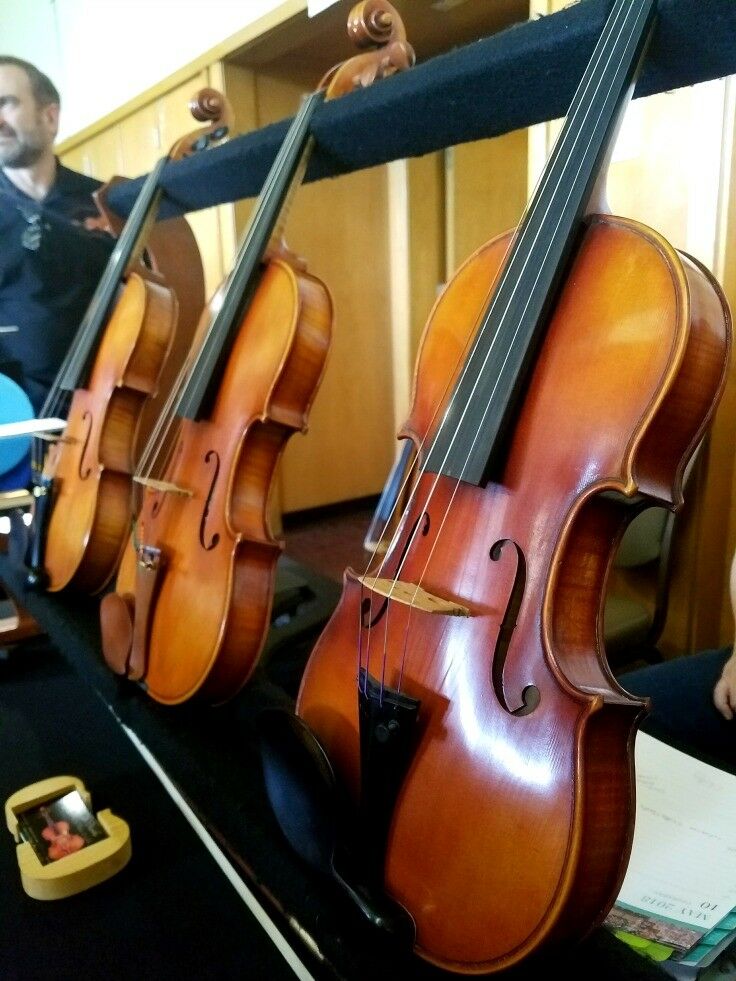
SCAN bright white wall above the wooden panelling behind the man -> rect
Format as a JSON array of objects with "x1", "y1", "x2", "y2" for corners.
[{"x1": 0, "y1": 0, "x2": 281, "y2": 140}]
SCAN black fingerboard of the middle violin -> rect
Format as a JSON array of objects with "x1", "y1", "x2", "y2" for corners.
[{"x1": 177, "y1": 90, "x2": 324, "y2": 419}]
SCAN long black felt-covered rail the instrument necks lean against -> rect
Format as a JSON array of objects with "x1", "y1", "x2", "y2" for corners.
[{"x1": 108, "y1": 0, "x2": 736, "y2": 217}]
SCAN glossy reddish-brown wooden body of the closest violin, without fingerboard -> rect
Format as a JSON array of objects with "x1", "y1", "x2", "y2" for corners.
[{"x1": 297, "y1": 216, "x2": 730, "y2": 973}]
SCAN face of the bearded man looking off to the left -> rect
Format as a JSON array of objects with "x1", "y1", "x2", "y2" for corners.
[{"x1": 0, "y1": 65, "x2": 59, "y2": 169}]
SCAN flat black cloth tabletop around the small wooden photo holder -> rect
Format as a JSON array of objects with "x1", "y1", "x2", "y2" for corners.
[{"x1": 0, "y1": 644, "x2": 314, "y2": 981}]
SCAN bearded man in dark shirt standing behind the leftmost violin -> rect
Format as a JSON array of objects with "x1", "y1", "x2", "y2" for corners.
[{"x1": 0, "y1": 55, "x2": 114, "y2": 440}]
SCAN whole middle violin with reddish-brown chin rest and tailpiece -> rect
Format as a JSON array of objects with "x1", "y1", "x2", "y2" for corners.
[{"x1": 100, "y1": 0, "x2": 413, "y2": 704}]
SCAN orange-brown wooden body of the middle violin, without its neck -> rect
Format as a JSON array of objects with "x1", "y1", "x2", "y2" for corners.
[{"x1": 112, "y1": 258, "x2": 332, "y2": 703}]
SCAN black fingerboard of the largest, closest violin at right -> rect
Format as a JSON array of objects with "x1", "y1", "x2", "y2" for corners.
[{"x1": 426, "y1": 0, "x2": 656, "y2": 486}]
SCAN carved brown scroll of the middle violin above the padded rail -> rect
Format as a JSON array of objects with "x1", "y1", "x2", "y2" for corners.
[{"x1": 319, "y1": 0, "x2": 416, "y2": 99}]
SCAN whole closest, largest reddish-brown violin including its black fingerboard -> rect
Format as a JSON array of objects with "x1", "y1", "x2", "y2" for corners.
[{"x1": 286, "y1": 0, "x2": 731, "y2": 973}]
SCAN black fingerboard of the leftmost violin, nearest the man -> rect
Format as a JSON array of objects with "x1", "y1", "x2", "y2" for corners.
[{"x1": 49, "y1": 157, "x2": 168, "y2": 400}]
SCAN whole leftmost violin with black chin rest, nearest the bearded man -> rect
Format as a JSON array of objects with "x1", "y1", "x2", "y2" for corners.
[{"x1": 26, "y1": 89, "x2": 232, "y2": 593}]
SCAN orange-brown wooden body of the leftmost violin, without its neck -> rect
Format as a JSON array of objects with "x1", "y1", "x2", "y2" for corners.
[{"x1": 44, "y1": 273, "x2": 178, "y2": 593}]
